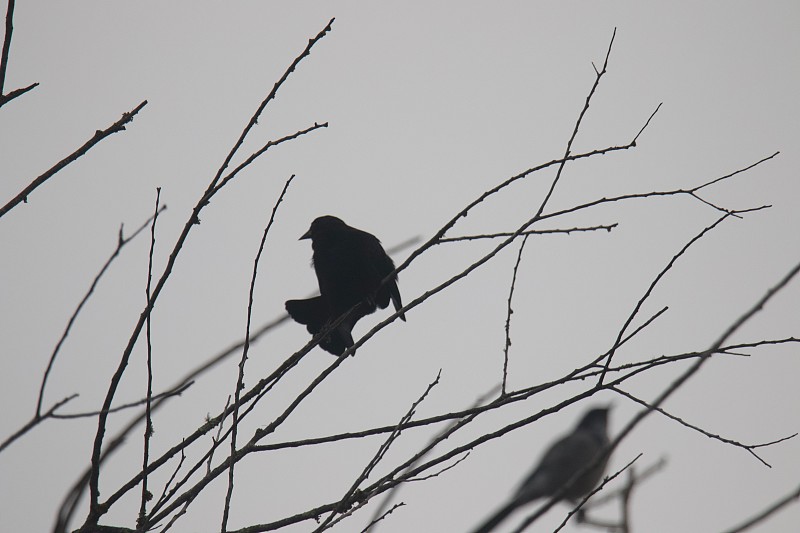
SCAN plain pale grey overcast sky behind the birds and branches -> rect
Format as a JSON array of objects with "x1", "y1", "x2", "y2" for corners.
[{"x1": 0, "y1": 1, "x2": 800, "y2": 533}]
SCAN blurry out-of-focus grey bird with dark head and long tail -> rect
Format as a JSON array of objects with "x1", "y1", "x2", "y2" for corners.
[{"x1": 473, "y1": 406, "x2": 609, "y2": 533}]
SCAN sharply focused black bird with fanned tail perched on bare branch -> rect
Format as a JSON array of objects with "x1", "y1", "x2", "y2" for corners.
[{"x1": 286, "y1": 215, "x2": 406, "y2": 356}]
